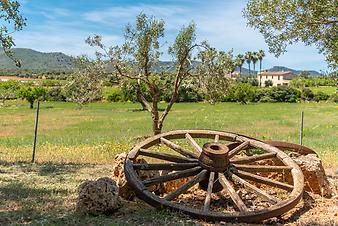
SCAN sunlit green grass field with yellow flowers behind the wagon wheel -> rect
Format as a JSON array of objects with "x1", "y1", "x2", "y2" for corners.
[{"x1": 0, "y1": 102, "x2": 338, "y2": 165}]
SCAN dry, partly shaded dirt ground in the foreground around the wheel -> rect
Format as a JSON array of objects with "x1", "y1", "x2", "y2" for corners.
[{"x1": 0, "y1": 161, "x2": 338, "y2": 226}]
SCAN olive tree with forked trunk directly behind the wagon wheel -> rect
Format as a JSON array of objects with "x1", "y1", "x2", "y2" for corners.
[{"x1": 87, "y1": 13, "x2": 209, "y2": 134}]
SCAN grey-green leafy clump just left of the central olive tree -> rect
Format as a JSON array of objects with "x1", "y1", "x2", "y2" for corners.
[{"x1": 64, "y1": 56, "x2": 104, "y2": 107}]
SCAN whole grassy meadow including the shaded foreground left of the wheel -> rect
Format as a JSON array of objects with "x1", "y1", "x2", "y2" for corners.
[{"x1": 0, "y1": 101, "x2": 338, "y2": 225}]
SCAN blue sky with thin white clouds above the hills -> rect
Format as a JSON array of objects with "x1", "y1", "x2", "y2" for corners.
[{"x1": 14, "y1": 0, "x2": 327, "y2": 71}]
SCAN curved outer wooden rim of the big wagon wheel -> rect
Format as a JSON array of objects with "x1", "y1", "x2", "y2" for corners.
[{"x1": 125, "y1": 130, "x2": 304, "y2": 222}]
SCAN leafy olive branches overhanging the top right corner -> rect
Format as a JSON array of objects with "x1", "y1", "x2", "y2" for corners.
[{"x1": 243, "y1": 0, "x2": 338, "y2": 69}]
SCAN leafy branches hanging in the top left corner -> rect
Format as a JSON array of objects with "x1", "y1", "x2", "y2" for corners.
[{"x1": 0, "y1": 0, "x2": 26, "y2": 67}]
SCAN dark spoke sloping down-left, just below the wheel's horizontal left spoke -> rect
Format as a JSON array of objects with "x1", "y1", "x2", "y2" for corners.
[{"x1": 142, "y1": 166, "x2": 202, "y2": 186}]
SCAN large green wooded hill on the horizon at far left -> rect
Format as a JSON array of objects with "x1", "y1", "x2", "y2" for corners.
[{"x1": 0, "y1": 48, "x2": 73, "y2": 71}]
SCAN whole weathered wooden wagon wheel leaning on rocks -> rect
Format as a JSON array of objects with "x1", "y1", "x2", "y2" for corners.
[{"x1": 124, "y1": 130, "x2": 304, "y2": 222}]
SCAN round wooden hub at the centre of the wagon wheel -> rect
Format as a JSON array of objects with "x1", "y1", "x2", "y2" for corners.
[{"x1": 198, "y1": 142, "x2": 229, "y2": 172}]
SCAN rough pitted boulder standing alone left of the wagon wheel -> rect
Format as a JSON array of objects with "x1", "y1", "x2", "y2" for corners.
[{"x1": 76, "y1": 177, "x2": 120, "y2": 215}]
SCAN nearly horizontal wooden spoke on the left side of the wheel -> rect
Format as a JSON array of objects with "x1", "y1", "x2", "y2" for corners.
[{"x1": 133, "y1": 162, "x2": 199, "y2": 170}]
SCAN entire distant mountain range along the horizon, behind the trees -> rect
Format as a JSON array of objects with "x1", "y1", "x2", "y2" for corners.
[{"x1": 0, "y1": 48, "x2": 320, "y2": 76}]
